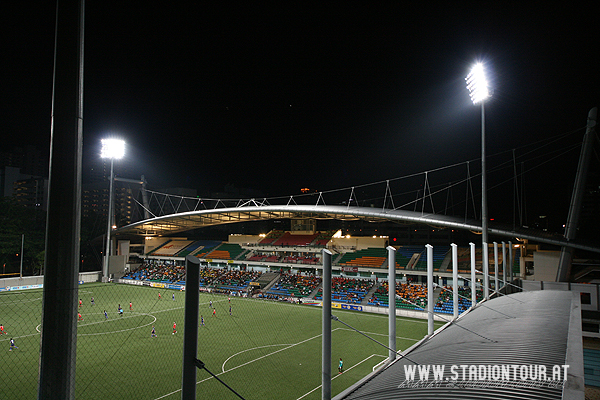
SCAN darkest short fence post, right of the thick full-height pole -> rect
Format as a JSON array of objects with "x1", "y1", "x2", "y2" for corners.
[{"x1": 181, "y1": 255, "x2": 200, "y2": 400}]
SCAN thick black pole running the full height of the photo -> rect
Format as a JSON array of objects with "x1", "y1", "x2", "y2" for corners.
[{"x1": 38, "y1": 0, "x2": 84, "y2": 400}]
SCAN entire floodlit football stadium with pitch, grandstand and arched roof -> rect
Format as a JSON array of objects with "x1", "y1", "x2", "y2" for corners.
[{"x1": 0, "y1": 110, "x2": 600, "y2": 400}]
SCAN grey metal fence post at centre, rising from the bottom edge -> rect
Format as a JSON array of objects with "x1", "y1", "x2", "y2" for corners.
[{"x1": 321, "y1": 250, "x2": 332, "y2": 400}]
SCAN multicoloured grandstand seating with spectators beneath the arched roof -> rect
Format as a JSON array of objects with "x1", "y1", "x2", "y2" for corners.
[{"x1": 124, "y1": 230, "x2": 519, "y2": 314}]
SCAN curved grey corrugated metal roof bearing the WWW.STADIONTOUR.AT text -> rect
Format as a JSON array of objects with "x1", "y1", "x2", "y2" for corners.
[{"x1": 336, "y1": 291, "x2": 583, "y2": 400}]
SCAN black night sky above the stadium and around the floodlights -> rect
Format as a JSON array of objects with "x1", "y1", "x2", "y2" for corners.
[{"x1": 0, "y1": 0, "x2": 600, "y2": 228}]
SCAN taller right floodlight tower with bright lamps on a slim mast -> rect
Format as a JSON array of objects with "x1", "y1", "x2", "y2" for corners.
[{"x1": 465, "y1": 63, "x2": 490, "y2": 287}]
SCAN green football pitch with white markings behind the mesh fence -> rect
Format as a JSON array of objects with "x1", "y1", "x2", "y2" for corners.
[{"x1": 0, "y1": 283, "x2": 440, "y2": 400}]
